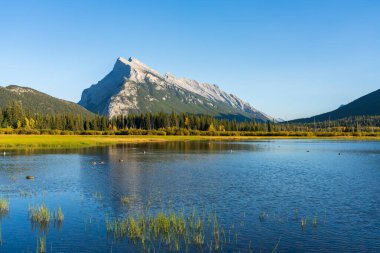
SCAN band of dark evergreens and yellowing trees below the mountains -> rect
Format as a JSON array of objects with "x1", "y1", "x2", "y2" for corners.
[{"x1": 0, "y1": 101, "x2": 380, "y2": 134}]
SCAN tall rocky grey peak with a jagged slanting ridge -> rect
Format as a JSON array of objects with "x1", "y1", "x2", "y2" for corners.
[{"x1": 79, "y1": 58, "x2": 273, "y2": 121}]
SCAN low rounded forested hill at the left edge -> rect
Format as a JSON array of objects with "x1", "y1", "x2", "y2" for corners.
[{"x1": 0, "y1": 85, "x2": 93, "y2": 117}]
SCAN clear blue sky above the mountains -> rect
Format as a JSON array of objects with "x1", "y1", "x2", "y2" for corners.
[{"x1": 0, "y1": 0, "x2": 380, "y2": 119}]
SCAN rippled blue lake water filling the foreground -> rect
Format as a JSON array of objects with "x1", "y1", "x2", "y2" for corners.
[{"x1": 0, "y1": 140, "x2": 380, "y2": 252}]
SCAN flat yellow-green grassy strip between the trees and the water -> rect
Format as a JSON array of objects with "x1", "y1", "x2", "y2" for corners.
[{"x1": 0, "y1": 135, "x2": 380, "y2": 149}]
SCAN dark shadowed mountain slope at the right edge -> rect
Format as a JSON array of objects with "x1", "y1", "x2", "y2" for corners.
[{"x1": 292, "y1": 89, "x2": 380, "y2": 122}]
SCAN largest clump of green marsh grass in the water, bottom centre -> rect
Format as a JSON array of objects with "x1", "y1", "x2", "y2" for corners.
[{"x1": 106, "y1": 210, "x2": 227, "y2": 252}]
